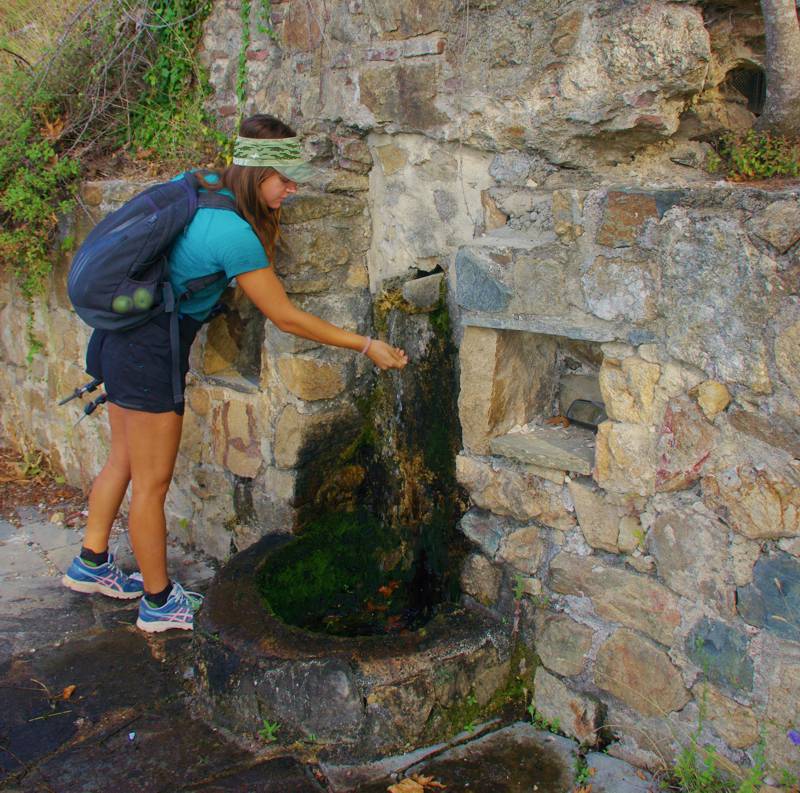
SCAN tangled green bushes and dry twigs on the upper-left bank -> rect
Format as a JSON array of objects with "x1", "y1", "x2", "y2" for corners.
[{"x1": 0, "y1": 0, "x2": 221, "y2": 299}]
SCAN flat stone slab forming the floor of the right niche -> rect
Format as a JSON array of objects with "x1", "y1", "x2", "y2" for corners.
[{"x1": 490, "y1": 427, "x2": 594, "y2": 476}]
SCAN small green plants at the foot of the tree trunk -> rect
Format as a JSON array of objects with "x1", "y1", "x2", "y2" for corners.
[{"x1": 706, "y1": 130, "x2": 800, "y2": 182}]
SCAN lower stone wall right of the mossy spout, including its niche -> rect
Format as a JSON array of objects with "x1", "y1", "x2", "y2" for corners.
[{"x1": 454, "y1": 185, "x2": 800, "y2": 768}]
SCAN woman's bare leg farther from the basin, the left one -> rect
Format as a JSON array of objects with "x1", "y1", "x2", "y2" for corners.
[{"x1": 83, "y1": 403, "x2": 131, "y2": 553}]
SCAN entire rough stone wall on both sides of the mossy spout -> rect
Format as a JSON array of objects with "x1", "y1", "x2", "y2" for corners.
[{"x1": 0, "y1": 0, "x2": 800, "y2": 770}]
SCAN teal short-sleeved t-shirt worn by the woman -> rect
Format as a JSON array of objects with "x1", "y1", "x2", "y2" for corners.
[{"x1": 169, "y1": 175, "x2": 269, "y2": 321}]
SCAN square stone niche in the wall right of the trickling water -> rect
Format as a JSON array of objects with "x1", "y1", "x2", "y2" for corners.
[{"x1": 459, "y1": 327, "x2": 603, "y2": 477}]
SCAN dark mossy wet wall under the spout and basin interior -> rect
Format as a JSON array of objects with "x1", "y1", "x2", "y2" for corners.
[{"x1": 266, "y1": 280, "x2": 465, "y2": 635}]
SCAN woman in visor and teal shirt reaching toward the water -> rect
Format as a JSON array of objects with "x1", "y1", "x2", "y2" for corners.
[{"x1": 63, "y1": 115, "x2": 408, "y2": 632}]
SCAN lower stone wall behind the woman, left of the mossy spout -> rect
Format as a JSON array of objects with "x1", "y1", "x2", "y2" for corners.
[{"x1": 0, "y1": 182, "x2": 371, "y2": 559}]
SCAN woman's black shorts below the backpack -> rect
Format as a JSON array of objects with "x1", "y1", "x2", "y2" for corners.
[{"x1": 86, "y1": 315, "x2": 202, "y2": 415}]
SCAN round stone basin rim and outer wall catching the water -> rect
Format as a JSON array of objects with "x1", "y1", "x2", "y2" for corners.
[{"x1": 194, "y1": 536, "x2": 512, "y2": 761}]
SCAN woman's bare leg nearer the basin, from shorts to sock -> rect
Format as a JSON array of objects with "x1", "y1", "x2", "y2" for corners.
[{"x1": 118, "y1": 408, "x2": 183, "y2": 594}]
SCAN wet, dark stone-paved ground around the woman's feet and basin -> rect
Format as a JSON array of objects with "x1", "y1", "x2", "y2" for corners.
[{"x1": 0, "y1": 448, "x2": 655, "y2": 793}]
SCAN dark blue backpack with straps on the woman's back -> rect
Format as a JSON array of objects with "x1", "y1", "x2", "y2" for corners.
[{"x1": 67, "y1": 172, "x2": 236, "y2": 405}]
